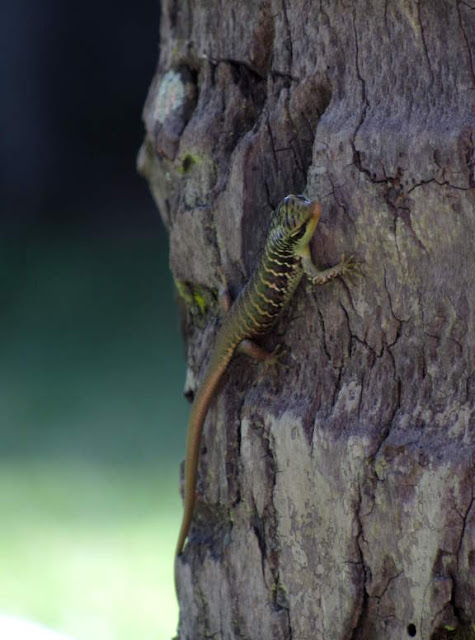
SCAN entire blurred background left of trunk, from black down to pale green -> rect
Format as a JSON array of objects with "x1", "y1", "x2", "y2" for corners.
[{"x1": 0, "y1": 0, "x2": 188, "y2": 640}]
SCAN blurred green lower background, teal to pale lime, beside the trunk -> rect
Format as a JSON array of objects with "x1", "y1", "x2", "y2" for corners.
[{"x1": 0, "y1": 237, "x2": 187, "y2": 640}]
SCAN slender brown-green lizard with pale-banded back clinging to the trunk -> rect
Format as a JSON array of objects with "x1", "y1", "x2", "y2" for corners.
[{"x1": 176, "y1": 195, "x2": 359, "y2": 556}]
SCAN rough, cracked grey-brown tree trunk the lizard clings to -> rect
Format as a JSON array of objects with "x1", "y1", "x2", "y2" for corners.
[{"x1": 139, "y1": 0, "x2": 475, "y2": 640}]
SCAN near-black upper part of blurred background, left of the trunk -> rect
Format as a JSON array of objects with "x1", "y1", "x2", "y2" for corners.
[{"x1": 0, "y1": 0, "x2": 162, "y2": 235}]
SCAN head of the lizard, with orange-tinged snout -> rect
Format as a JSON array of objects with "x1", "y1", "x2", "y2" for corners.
[{"x1": 271, "y1": 195, "x2": 322, "y2": 249}]
